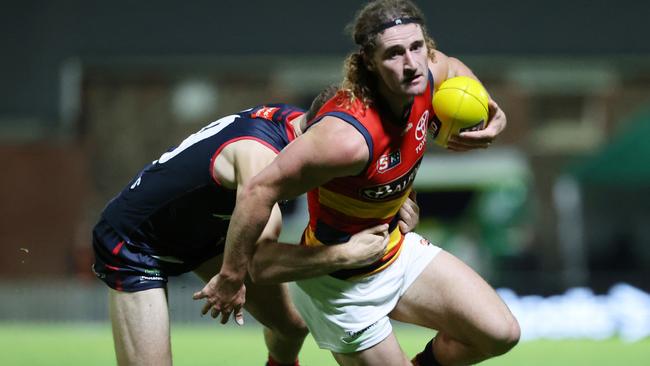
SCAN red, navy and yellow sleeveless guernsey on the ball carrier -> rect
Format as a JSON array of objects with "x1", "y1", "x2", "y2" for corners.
[{"x1": 303, "y1": 73, "x2": 433, "y2": 278}]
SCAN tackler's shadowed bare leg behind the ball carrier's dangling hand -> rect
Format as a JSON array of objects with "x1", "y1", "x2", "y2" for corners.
[{"x1": 194, "y1": 255, "x2": 309, "y2": 365}]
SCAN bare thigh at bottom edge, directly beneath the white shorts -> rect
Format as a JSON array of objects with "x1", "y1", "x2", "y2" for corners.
[{"x1": 332, "y1": 332, "x2": 411, "y2": 366}]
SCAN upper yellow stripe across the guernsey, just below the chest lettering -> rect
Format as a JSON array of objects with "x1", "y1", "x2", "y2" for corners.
[{"x1": 318, "y1": 187, "x2": 409, "y2": 219}]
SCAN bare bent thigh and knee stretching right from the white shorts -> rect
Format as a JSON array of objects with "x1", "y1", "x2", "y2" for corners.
[{"x1": 390, "y1": 251, "x2": 516, "y2": 345}]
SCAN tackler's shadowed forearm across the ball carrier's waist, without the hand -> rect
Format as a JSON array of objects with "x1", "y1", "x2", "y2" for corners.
[{"x1": 249, "y1": 243, "x2": 350, "y2": 284}]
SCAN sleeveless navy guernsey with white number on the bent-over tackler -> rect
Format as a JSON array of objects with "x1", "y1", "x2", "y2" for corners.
[{"x1": 102, "y1": 104, "x2": 304, "y2": 259}]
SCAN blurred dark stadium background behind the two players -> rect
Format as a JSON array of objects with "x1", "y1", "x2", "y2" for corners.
[{"x1": 0, "y1": 0, "x2": 650, "y2": 365}]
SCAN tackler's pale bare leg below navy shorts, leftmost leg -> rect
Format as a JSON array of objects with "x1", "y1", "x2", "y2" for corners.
[{"x1": 109, "y1": 288, "x2": 172, "y2": 366}]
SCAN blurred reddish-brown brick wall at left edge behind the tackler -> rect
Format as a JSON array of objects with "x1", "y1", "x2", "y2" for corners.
[{"x1": 0, "y1": 143, "x2": 90, "y2": 278}]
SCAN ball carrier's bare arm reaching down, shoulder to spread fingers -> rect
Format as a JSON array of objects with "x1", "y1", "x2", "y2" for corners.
[{"x1": 200, "y1": 117, "x2": 370, "y2": 319}]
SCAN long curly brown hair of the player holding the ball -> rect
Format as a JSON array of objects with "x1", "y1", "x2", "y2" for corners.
[{"x1": 341, "y1": 0, "x2": 436, "y2": 106}]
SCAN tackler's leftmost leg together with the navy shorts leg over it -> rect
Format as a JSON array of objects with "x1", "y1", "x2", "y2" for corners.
[{"x1": 93, "y1": 220, "x2": 172, "y2": 365}]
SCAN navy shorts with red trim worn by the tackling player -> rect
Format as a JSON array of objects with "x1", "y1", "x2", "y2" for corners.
[{"x1": 93, "y1": 218, "x2": 223, "y2": 292}]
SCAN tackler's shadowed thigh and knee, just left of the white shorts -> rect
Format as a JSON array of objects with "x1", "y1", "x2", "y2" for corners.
[{"x1": 244, "y1": 281, "x2": 308, "y2": 337}]
